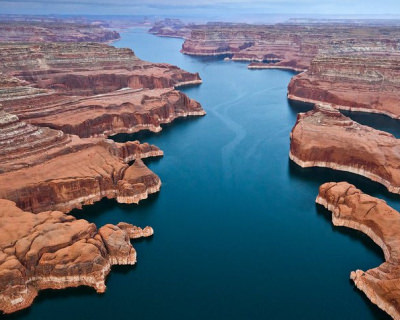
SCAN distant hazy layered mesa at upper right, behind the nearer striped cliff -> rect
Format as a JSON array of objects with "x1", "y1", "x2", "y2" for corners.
[{"x1": 182, "y1": 23, "x2": 400, "y2": 71}]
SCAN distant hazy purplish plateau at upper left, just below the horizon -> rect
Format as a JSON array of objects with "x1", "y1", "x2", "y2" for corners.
[{"x1": 0, "y1": 20, "x2": 120, "y2": 42}]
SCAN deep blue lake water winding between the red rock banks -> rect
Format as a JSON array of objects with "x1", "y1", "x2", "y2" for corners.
[{"x1": 7, "y1": 29, "x2": 400, "y2": 320}]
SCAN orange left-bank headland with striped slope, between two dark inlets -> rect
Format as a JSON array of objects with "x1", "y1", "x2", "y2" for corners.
[{"x1": 0, "y1": 106, "x2": 162, "y2": 212}]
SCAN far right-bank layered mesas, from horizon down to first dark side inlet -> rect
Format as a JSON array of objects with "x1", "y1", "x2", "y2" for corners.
[{"x1": 152, "y1": 20, "x2": 400, "y2": 118}]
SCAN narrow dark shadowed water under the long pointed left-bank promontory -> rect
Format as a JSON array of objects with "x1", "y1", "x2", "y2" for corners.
[{"x1": 110, "y1": 116, "x2": 203, "y2": 142}]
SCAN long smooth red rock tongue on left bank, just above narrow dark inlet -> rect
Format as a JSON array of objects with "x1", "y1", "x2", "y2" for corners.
[{"x1": 4, "y1": 88, "x2": 205, "y2": 137}]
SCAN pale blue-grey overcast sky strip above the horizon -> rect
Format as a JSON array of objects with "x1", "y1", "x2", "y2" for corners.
[{"x1": 0, "y1": 0, "x2": 400, "y2": 15}]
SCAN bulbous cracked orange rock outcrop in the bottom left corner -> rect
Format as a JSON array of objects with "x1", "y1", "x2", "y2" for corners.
[{"x1": 0, "y1": 199, "x2": 153, "y2": 313}]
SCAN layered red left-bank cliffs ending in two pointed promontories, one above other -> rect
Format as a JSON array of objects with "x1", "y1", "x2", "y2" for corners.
[{"x1": 0, "y1": 43, "x2": 205, "y2": 137}]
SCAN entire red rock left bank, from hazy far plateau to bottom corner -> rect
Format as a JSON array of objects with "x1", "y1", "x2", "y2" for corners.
[{"x1": 0, "y1": 21, "x2": 205, "y2": 313}]
